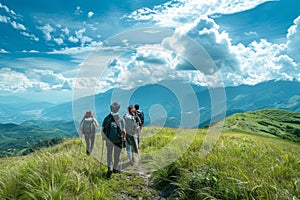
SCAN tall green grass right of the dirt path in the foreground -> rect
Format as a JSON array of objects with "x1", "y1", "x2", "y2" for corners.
[{"x1": 153, "y1": 132, "x2": 300, "y2": 199}]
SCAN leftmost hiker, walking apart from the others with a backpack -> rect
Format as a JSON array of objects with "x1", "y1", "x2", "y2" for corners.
[{"x1": 80, "y1": 110, "x2": 98, "y2": 155}]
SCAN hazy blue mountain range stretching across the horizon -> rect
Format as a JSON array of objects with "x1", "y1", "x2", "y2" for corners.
[{"x1": 0, "y1": 81, "x2": 300, "y2": 127}]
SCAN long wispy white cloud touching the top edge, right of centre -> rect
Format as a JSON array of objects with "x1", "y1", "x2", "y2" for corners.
[{"x1": 125, "y1": 0, "x2": 270, "y2": 27}]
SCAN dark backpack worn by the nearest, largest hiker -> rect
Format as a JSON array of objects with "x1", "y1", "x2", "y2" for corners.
[{"x1": 104, "y1": 115, "x2": 122, "y2": 144}]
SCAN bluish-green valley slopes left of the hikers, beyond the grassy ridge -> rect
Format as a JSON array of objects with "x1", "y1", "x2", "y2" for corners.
[{"x1": 0, "y1": 120, "x2": 77, "y2": 158}]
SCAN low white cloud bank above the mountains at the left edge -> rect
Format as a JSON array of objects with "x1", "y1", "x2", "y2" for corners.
[{"x1": 0, "y1": 68, "x2": 73, "y2": 93}]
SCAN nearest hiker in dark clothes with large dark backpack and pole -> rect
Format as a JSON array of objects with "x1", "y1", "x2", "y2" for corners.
[{"x1": 102, "y1": 102, "x2": 126, "y2": 178}]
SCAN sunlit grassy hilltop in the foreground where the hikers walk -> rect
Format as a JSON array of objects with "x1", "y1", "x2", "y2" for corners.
[{"x1": 0, "y1": 122, "x2": 300, "y2": 199}]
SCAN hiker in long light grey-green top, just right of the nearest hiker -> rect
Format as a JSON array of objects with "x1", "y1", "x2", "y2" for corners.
[{"x1": 124, "y1": 105, "x2": 139, "y2": 165}]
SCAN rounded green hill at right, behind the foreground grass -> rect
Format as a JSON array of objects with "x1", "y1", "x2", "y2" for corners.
[{"x1": 225, "y1": 109, "x2": 300, "y2": 142}]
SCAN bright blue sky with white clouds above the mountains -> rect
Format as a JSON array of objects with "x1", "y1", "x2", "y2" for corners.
[{"x1": 0, "y1": 0, "x2": 300, "y2": 102}]
